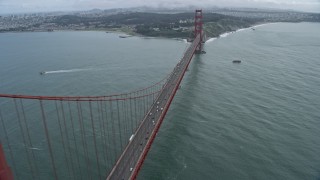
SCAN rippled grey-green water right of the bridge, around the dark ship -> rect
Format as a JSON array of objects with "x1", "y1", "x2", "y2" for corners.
[{"x1": 139, "y1": 23, "x2": 320, "y2": 180}]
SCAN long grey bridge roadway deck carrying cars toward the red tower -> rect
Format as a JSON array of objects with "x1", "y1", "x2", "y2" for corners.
[{"x1": 107, "y1": 35, "x2": 200, "y2": 180}]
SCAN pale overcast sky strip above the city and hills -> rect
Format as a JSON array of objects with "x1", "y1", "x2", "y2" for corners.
[{"x1": 0, "y1": 0, "x2": 320, "y2": 14}]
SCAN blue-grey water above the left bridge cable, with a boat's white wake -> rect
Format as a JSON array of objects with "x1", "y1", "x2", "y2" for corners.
[{"x1": 0, "y1": 32, "x2": 187, "y2": 95}]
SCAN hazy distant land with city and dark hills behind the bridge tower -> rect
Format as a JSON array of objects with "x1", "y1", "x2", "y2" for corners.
[{"x1": 0, "y1": 7, "x2": 320, "y2": 38}]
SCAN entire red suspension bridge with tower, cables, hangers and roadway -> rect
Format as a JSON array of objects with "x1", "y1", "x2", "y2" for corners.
[{"x1": 0, "y1": 10, "x2": 204, "y2": 180}]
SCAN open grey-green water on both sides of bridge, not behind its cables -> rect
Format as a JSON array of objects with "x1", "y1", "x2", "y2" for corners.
[{"x1": 0, "y1": 23, "x2": 320, "y2": 180}]
